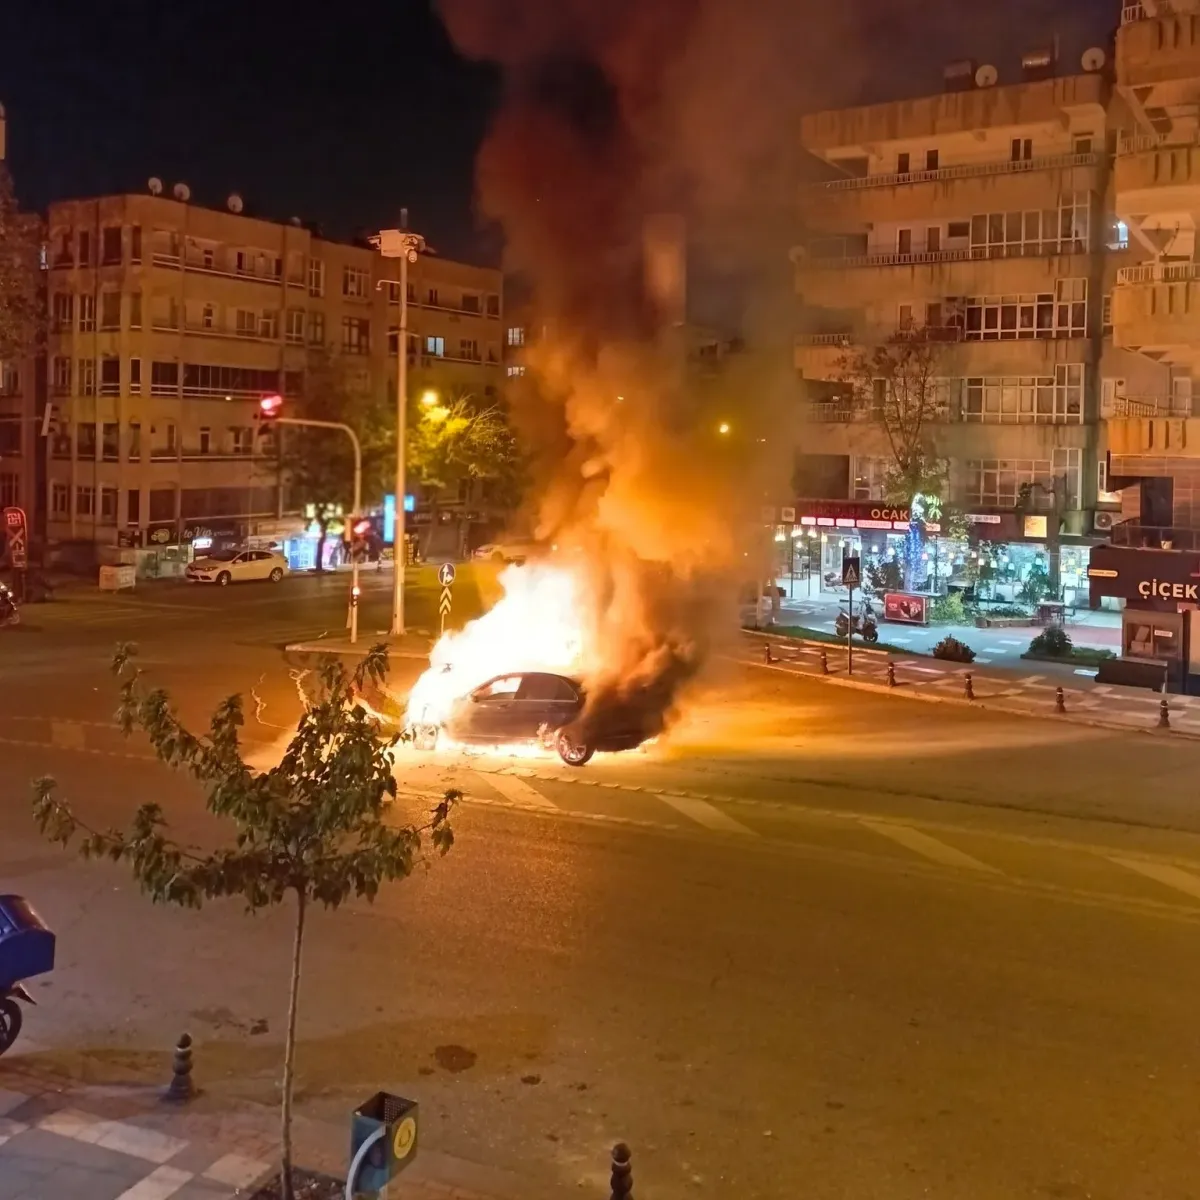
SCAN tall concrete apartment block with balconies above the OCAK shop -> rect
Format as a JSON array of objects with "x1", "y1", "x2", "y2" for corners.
[{"x1": 793, "y1": 0, "x2": 1200, "y2": 599}]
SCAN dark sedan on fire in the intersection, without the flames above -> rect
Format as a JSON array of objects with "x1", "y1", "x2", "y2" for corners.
[{"x1": 409, "y1": 671, "x2": 647, "y2": 767}]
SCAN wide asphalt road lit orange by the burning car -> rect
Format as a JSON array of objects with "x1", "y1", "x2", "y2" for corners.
[{"x1": 0, "y1": 577, "x2": 1200, "y2": 1200}]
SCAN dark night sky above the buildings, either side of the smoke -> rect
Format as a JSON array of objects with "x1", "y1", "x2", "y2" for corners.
[{"x1": 0, "y1": 0, "x2": 1120, "y2": 265}]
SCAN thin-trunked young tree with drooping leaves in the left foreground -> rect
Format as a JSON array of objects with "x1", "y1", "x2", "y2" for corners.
[{"x1": 34, "y1": 646, "x2": 461, "y2": 1200}]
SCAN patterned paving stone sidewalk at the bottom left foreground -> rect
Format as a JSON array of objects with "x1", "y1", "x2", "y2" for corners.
[{"x1": 0, "y1": 1064, "x2": 496, "y2": 1200}]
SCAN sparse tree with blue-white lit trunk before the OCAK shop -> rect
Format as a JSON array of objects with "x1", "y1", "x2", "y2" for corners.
[{"x1": 838, "y1": 329, "x2": 947, "y2": 588}]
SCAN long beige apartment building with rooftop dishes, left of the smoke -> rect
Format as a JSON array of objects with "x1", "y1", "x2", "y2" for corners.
[{"x1": 46, "y1": 190, "x2": 504, "y2": 546}]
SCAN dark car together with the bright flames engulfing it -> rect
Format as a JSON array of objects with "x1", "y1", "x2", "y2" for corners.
[{"x1": 404, "y1": 560, "x2": 660, "y2": 767}]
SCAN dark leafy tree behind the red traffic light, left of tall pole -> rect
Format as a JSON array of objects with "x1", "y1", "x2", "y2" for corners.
[{"x1": 280, "y1": 352, "x2": 396, "y2": 571}]
